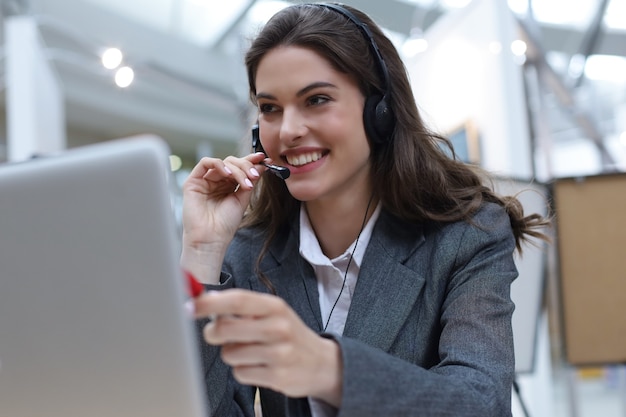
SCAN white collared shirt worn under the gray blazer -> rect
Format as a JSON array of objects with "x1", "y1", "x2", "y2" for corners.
[{"x1": 300, "y1": 204, "x2": 381, "y2": 417}]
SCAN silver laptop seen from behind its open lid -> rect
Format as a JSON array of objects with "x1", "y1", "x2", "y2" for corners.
[{"x1": 0, "y1": 137, "x2": 208, "y2": 417}]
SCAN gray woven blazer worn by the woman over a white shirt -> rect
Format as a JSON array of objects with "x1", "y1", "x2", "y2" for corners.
[{"x1": 198, "y1": 203, "x2": 517, "y2": 417}]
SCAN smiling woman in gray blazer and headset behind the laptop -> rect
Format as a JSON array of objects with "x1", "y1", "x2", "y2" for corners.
[{"x1": 181, "y1": 4, "x2": 545, "y2": 417}]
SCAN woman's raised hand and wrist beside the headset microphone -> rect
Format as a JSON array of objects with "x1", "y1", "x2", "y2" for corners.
[{"x1": 181, "y1": 153, "x2": 265, "y2": 284}]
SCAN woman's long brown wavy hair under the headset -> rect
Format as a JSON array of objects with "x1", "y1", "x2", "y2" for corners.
[{"x1": 242, "y1": 4, "x2": 549, "y2": 280}]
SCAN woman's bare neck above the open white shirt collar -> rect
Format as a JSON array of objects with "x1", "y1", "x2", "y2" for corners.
[{"x1": 305, "y1": 193, "x2": 377, "y2": 259}]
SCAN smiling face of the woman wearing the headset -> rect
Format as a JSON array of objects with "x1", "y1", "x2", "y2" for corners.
[{"x1": 256, "y1": 46, "x2": 370, "y2": 201}]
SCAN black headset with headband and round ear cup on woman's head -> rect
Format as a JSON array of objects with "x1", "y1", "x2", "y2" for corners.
[{"x1": 252, "y1": 3, "x2": 395, "y2": 152}]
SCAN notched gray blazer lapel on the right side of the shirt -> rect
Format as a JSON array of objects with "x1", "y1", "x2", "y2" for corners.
[{"x1": 344, "y1": 211, "x2": 425, "y2": 351}]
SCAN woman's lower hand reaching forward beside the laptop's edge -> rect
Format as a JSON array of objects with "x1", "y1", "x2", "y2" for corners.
[{"x1": 195, "y1": 289, "x2": 342, "y2": 407}]
